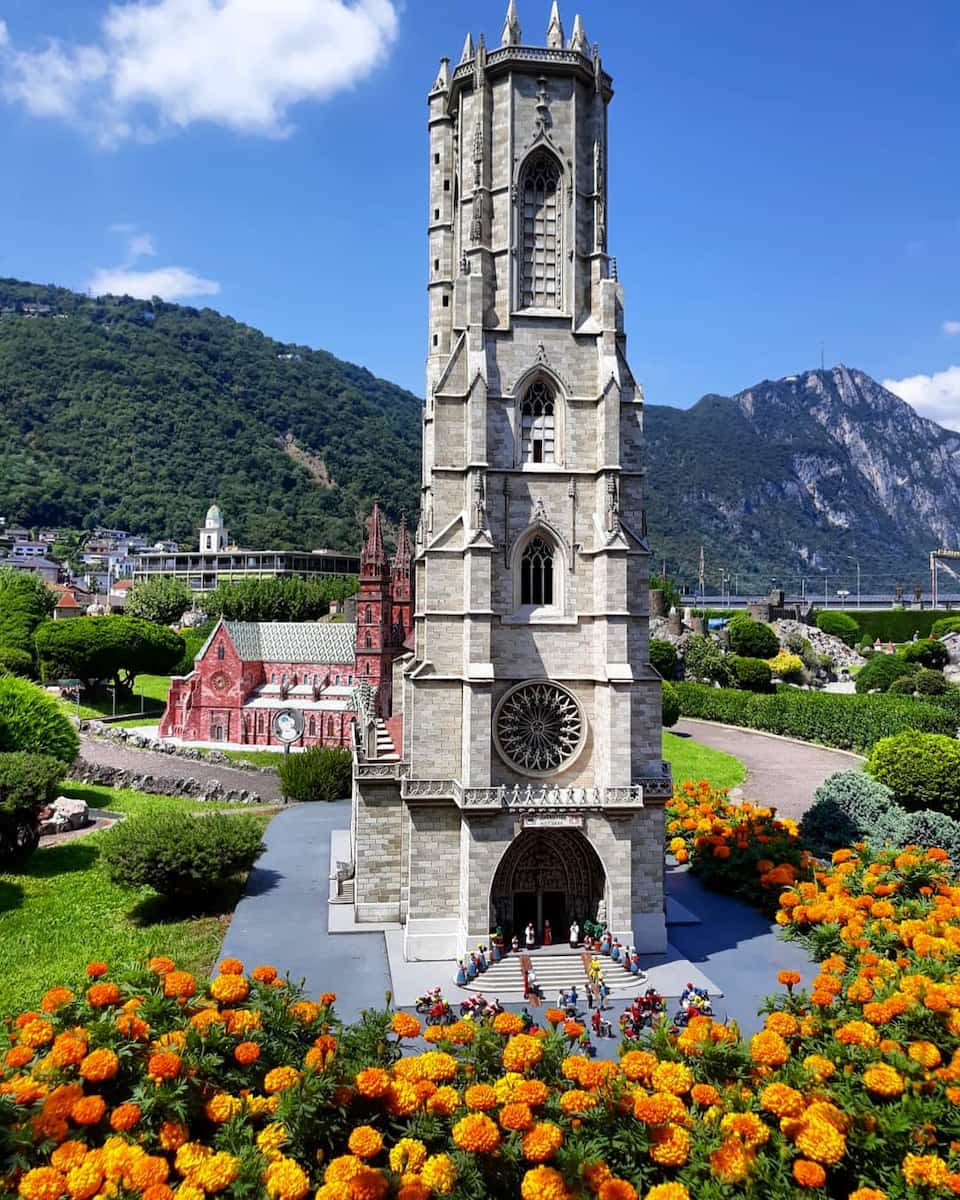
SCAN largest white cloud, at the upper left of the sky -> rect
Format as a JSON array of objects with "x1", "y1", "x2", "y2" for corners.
[{"x1": 0, "y1": 0, "x2": 398, "y2": 144}]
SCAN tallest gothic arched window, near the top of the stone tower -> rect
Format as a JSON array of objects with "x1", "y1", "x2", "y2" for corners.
[{"x1": 520, "y1": 151, "x2": 563, "y2": 308}]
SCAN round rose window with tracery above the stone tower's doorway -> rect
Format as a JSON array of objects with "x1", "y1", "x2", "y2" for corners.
[{"x1": 494, "y1": 680, "x2": 584, "y2": 775}]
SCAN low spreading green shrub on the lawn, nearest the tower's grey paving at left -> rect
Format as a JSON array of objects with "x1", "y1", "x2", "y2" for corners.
[{"x1": 100, "y1": 809, "x2": 265, "y2": 902}]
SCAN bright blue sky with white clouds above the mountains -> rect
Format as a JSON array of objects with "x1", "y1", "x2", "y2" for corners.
[{"x1": 0, "y1": 0, "x2": 960, "y2": 427}]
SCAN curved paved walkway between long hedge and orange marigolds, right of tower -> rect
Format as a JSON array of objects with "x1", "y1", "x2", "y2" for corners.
[{"x1": 671, "y1": 718, "x2": 864, "y2": 820}]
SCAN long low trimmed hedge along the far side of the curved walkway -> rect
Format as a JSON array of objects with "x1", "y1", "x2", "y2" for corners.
[{"x1": 674, "y1": 683, "x2": 956, "y2": 751}]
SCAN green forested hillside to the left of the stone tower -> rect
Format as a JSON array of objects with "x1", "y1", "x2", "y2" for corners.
[{"x1": 0, "y1": 280, "x2": 420, "y2": 550}]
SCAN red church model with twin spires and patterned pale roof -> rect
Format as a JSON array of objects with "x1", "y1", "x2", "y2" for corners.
[{"x1": 160, "y1": 504, "x2": 413, "y2": 746}]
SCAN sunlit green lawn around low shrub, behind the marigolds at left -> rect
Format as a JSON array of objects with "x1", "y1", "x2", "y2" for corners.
[{"x1": 0, "y1": 787, "x2": 269, "y2": 1013}]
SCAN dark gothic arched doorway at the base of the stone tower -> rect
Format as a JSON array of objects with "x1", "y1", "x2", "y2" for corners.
[{"x1": 490, "y1": 829, "x2": 606, "y2": 941}]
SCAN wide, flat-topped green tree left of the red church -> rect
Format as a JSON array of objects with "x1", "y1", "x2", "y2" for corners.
[{"x1": 35, "y1": 617, "x2": 185, "y2": 691}]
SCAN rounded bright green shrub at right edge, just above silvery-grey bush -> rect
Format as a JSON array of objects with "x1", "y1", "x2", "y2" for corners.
[{"x1": 866, "y1": 729, "x2": 960, "y2": 816}]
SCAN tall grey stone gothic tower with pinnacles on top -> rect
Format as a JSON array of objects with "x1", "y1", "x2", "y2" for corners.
[{"x1": 353, "y1": 2, "x2": 671, "y2": 959}]
